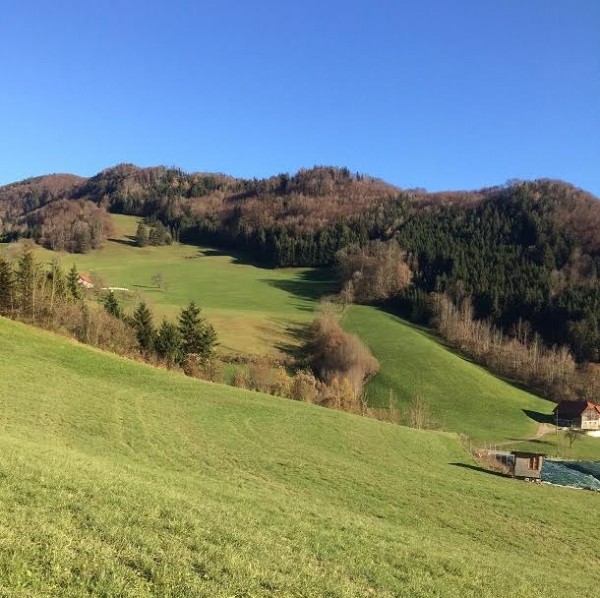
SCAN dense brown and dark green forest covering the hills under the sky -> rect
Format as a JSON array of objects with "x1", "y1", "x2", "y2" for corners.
[{"x1": 0, "y1": 165, "x2": 600, "y2": 362}]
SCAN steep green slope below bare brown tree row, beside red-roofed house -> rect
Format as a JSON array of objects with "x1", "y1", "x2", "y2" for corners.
[{"x1": 343, "y1": 306, "x2": 554, "y2": 442}]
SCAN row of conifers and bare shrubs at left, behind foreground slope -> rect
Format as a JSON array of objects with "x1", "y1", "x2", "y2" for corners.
[{"x1": 0, "y1": 250, "x2": 217, "y2": 368}]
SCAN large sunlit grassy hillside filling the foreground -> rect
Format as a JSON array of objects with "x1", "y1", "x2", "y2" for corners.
[{"x1": 0, "y1": 312, "x2": 600, "y2": 597}]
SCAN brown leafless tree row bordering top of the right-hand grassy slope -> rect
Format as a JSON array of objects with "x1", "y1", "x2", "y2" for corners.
[{"x1": 336, "y1": 240, "x2": 600, "y2": 401}]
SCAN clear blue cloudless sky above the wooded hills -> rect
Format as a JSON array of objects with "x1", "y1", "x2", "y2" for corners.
[{"x1": 0, "y1": 0, "x2": 600, "y2": 195}]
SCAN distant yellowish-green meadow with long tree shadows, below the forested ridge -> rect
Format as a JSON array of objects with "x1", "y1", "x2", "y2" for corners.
[{"x1": 3, "y1": 215, "x2": 330, "y2": 353}]
